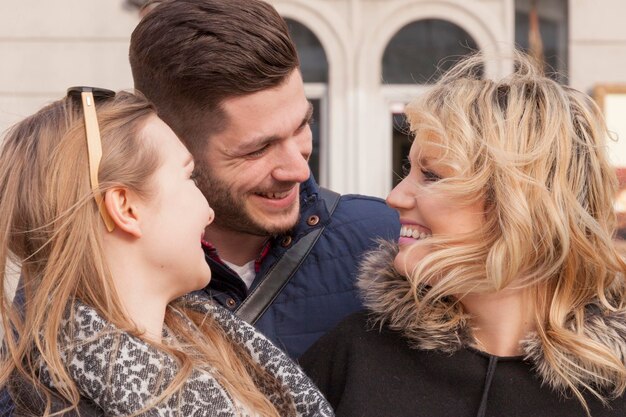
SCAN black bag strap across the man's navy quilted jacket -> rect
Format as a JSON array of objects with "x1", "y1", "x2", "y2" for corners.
[{"x1": 235, "y1": 188, "x2": 341, "y2": 324}]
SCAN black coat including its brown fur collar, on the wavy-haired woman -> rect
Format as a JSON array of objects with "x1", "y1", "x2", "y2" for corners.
[{"x1": 300, "y1": 240, "x2": 626, "y2": 417}]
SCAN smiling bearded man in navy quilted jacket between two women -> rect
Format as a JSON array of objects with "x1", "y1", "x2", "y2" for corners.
[{"x1": 130, "y1": 0, "x2": 400, "y2": 358}]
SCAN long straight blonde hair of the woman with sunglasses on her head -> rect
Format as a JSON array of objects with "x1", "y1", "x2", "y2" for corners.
[{"x1": 0, "y1": 92, "x2": 278, "y2": 416}]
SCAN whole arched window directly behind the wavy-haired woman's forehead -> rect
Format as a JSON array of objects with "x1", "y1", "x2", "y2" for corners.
[{"x1": 382, "y1": 19, "x2": 478, "y2": 186}]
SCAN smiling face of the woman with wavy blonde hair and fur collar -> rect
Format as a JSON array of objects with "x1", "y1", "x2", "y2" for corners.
[{"x1": 387, "y1": 140, "x2": 484, "y2": 276}]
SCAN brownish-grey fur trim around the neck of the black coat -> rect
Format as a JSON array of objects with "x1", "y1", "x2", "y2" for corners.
[{"x1": 357, "y1": 241, "x2": 626, "y2": 397}]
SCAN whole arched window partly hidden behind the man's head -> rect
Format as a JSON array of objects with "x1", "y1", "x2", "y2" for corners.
[{"x1": 285, "y1": 18, "x2": 328, "y2": 183}]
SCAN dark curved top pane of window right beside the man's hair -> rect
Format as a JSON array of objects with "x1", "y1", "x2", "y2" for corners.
[{"x1": 285, "y1": 19, "x2": 328, "y2": 83}]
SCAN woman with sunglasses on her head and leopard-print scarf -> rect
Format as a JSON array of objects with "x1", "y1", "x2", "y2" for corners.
[{"x1": 0, "y1": 87, "x2": 332, "y2": 417}]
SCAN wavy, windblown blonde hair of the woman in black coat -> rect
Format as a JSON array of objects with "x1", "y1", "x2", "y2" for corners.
[{"x1": 406, "y1": 53, "x2": 626, "y2": 407}]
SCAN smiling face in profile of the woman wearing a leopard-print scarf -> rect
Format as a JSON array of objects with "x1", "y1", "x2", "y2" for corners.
[{"x1": 139, "y1": 117, "x2": 214, "y2": 299}]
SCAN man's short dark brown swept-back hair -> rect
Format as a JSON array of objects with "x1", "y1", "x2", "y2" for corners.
[{"x1": 130, "y1": 0, "x2": 299, "y2": 154}]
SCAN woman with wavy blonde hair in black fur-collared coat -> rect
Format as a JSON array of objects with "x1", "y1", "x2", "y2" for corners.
[{"x1": 301, "y1": 54, "x2": 626, "y2": 417}]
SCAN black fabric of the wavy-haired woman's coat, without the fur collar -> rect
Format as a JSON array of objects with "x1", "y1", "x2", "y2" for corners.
[{"x1": 300, "y1": 312, "x2": 626, "y2": 417}]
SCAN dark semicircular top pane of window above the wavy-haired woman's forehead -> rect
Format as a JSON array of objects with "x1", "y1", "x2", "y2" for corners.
[{"x1": 383, "y1": 19, "x2": 478, "y2": 84}]
